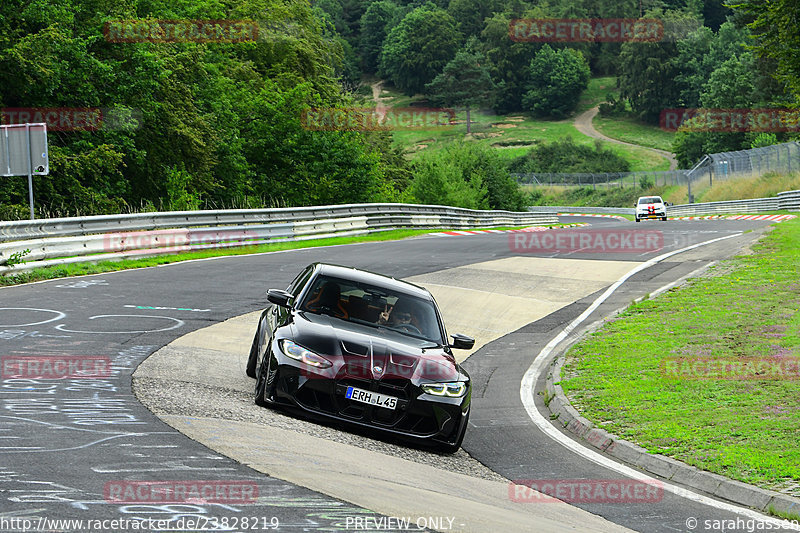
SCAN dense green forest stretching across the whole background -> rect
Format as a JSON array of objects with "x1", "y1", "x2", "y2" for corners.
[{"x1": 0, "y1": 0, "x2": 800, "y2": 220}]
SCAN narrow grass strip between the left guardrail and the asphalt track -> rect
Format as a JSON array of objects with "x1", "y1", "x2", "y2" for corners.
[{"x1": 0, "y1": 224, "x2": 563, "y2": 286}]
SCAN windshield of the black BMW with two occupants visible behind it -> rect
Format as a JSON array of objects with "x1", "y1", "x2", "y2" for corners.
[{"x1": 298, "y1": 276, "x2": 442, "y2": 345}]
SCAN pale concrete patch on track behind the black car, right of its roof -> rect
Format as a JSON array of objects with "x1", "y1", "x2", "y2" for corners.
[{"x1": 407, "y1": 257, "x2": 640, "y2": 361}]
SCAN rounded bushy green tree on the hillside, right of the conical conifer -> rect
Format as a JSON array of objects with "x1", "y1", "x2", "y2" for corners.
[{"x1": 522, "y1": 44, "x2": 591, "y2": 118}]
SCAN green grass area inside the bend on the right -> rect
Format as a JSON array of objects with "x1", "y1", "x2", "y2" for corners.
[{"x1": 561, "y1": 219, "x2": 800, "y2": 496}]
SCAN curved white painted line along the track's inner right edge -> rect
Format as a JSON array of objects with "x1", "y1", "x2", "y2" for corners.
[{"x1": 519, "y1": 233, "x2": 800, "y2": 531}]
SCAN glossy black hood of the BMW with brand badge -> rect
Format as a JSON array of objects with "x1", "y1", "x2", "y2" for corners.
[{"x1": 281, "y1": 312, "x2": 462, "y2": 382}]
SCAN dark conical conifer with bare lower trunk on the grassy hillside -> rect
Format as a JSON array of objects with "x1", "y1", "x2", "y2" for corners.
[{"x1": 425, "y1": 38, "x2": 495, "y2": 133}]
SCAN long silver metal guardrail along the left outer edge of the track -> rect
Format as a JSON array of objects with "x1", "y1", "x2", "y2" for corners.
[{"x1": 0, "y1": 204, "x2": 558, "y2": 274}]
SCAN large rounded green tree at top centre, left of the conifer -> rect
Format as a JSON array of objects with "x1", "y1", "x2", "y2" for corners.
[{"x1": 379, "y1": 2, "x2": 461, "y2": 96}]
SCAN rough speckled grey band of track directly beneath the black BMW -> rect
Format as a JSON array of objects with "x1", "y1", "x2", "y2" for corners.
[{"x1": 133, "y1": 377, "x2": 508, "y2": 482}]
